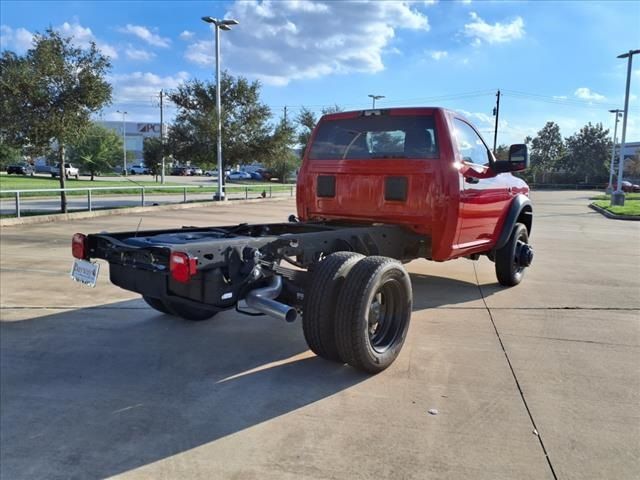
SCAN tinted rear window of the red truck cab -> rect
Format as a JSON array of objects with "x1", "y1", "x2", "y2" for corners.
[{"x1": 309, "y1": 113, "x2": 439, "y2": 160}]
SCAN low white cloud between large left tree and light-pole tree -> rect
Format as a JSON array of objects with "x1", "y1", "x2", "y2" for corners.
[{"x1": 107, "y1": 72, "x2": 189, "y2": 103}]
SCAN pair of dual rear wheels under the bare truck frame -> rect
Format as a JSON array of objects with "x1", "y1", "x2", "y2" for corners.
[{"x1": 303, "y1": 252, "x2": 412, "y2": 373}]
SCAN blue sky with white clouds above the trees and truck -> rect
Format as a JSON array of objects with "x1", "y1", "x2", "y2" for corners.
[{"x1": 0, "y1": 0, "x2": 640, "y2": 144}]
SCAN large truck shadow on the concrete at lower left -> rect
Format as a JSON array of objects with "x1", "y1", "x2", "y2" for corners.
[{"x1": 0, "y1": 301, "x2": 368, "y2": 479}]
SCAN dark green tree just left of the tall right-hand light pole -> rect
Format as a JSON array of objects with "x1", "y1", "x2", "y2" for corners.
[{"x1": 562, "y1": 122, "x2": 612, "y2": 183}]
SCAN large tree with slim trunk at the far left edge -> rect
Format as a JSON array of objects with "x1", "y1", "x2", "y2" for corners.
[{"x1": 0, "y1": 28, "x2": 111, "y2": 213}]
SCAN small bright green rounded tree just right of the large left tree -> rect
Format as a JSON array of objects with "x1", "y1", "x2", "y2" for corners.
[{"x1": 69, "y1": 123, "x2": 122, "y2": 181}]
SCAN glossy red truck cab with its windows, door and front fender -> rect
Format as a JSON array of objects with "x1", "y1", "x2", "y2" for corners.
[{"x1": 297, "y1": 108, "x2": 531, "y2": 261}]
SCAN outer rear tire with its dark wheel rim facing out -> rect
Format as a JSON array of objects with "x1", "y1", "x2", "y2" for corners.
[{"x1": 336, "y1": 256, "x2": 412, "y2": 373}]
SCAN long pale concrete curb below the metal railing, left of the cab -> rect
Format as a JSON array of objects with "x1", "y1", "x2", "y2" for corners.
[{"x1": 0, "y1": 196, "x2": 295, "y2": 227}]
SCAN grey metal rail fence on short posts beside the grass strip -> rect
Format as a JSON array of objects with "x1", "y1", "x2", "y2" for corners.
[{"x1": 0, "y1": 184, "x2": 296, "y2": 218}]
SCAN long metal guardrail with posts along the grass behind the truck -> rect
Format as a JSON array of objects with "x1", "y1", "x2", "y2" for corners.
[{"x1": 0, "y1": 184, "x2": 296, "y2": 218}]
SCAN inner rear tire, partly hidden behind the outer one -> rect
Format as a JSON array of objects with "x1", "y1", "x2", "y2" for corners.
[{"x1": 302, "y1": 252, "x2": 363, "y2": 361}]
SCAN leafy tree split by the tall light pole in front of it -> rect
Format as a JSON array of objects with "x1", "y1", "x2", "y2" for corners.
[{"x1": 169, "y1": 72, "x2": 271, "y2": 169}]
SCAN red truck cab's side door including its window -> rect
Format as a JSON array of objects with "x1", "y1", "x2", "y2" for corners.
[{"x1": 453, "y1": 118, "x2": 509, "y2": 249}]
